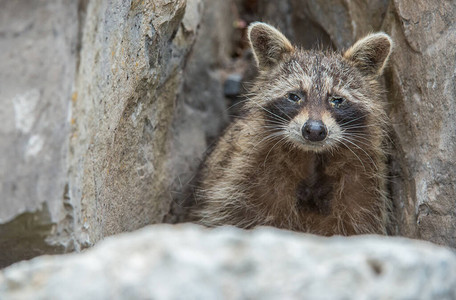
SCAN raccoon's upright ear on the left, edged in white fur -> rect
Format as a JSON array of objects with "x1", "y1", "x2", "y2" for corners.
[{"x1": 248, "y1": 22, "x2": 294, "y2": 70}]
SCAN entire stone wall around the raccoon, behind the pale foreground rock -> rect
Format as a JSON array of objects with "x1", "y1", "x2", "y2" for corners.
[{"x1": 0, "y1": 0, "x2": 456, "y2": 267}]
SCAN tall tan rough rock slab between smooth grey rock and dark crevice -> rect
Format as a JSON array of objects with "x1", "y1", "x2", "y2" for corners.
[{"x1": 70, "y1": 1, "x2": 196, "y2": 244}]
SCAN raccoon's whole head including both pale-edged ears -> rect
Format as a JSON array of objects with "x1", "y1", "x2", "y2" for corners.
[{"x1": 246, "y1": 23, "x2": 392, "y2": 152}]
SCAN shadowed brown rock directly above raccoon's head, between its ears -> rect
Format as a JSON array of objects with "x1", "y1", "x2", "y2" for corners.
[{"x1": 258, "y1": 0, "x2": 389, "y2": 49}]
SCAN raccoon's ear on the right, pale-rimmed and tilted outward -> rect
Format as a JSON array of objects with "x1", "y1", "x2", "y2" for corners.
[{"x1": 344, "y1": 32, "x2": 393, "y2": 75}]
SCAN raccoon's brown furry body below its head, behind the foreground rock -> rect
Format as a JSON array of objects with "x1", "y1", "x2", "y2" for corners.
[{"x1": 197, "y1": 122, "x2": 385, "y2": 235}]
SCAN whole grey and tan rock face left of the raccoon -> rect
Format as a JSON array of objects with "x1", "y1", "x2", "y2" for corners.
[{"x1": 0, "y1": 0, "x2": 232, "y2": 267}]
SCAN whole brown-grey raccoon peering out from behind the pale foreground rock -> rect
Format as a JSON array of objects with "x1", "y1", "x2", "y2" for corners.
[{"x1": 196, "y1": 23, "x2": 392, "y2": 235}]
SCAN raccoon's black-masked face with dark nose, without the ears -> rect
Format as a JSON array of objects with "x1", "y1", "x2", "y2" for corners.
[{"x1": 257, "y1": 52, "x2": 373, "y2": 152}]
